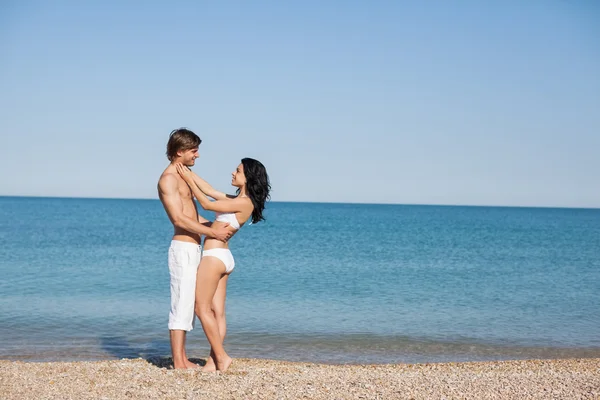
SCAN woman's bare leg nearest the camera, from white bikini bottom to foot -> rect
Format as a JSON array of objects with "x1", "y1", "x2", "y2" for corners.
[{"x1": 196, "y1": 256, "x2": 232, "y2": 371}]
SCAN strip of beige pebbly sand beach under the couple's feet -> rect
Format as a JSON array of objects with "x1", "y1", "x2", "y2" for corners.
[{"x1": 0, "y1": 358, "x2": 600, "y2": 399}]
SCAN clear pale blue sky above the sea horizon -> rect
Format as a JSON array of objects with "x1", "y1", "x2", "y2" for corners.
[{"x1": 0, "y1": 0, "x2": 600, "y2": 207}]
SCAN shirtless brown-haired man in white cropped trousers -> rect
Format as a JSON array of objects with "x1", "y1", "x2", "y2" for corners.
[{"x1": 158, "y1": 128, "x2": 231, "y2": 369}]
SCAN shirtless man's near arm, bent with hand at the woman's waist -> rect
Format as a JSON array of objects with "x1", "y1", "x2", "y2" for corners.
[{"x1": 158, "y1": 175, "x2": 232, "y2": 241}]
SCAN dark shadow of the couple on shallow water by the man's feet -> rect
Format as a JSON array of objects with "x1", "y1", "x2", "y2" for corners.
[{"x1": 100, "y1": 336, "x2": 206, "y2": 369}]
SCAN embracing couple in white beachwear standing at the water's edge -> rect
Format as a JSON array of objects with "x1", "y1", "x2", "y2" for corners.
[{"x1": 158, "y1": 128, "x2": 271, "y2": 372}]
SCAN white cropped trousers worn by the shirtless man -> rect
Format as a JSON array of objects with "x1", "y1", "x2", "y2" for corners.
[{"x1": 169, "y1": 240, "x2": 202, "y2": 331}]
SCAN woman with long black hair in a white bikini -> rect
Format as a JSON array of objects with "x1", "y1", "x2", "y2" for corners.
[{"x1": 176, "y1": 158, "x2": 271, "y2": 372}]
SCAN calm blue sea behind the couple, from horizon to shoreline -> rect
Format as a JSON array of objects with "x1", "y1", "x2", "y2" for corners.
[{"x1": 0, "y1": 197, "x2": 600, "y2": 363}]
